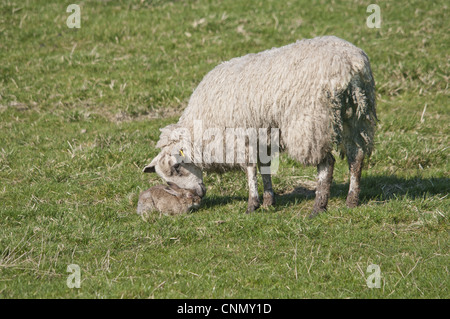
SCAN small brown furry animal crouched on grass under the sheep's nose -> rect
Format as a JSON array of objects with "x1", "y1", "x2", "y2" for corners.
[{"x1": 137, "y1": 183, "x2": 201, "y2": 215}]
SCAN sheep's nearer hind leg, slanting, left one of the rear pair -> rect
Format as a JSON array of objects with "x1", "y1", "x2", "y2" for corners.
[{"x1": 309, "y1": 154, "x2": 335, "y2": 218}]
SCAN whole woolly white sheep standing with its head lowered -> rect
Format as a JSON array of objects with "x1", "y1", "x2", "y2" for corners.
[{"x1": 144, "y1": 36, "x2": 377, "y2": 216}]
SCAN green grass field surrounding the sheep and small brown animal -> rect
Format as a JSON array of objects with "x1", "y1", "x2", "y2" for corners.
[{"x1": 0, "y1": 0, "x2": 450, "y2": 298}]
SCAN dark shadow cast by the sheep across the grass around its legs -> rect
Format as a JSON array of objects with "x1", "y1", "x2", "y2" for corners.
[{"x1": 202, "y1": 175, "x2": 450, "y2": 209}]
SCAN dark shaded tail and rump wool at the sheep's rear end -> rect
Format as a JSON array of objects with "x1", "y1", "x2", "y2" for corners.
[{"x1": 335, "y1": 56, "x2": 378, "y2": 160}]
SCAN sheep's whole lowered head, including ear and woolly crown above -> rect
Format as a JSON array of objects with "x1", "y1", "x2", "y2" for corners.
[{"x1": 144, "y1": 125, "x2": 206, "y2": 197}]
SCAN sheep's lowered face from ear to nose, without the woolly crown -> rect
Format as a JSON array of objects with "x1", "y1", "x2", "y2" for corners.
[{"x1": 144, "y1": 150, "x2": 206, "y2": 197}]
